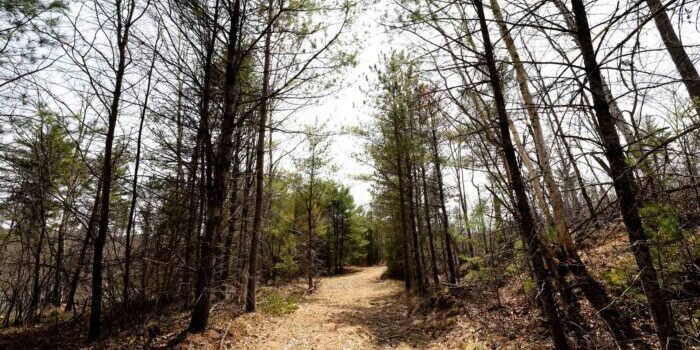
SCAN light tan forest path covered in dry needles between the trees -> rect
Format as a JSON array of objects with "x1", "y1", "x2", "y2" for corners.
[{"x1": 228, "y1": 267, "x2": 464, "y2": 350}]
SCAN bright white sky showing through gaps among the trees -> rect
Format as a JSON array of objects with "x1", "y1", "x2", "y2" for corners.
[{"x1": 5, "y1": 0, "x2": 700, "y2": 219}]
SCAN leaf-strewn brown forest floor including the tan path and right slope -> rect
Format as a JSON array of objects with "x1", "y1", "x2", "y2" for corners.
[{"x1": 0, "y1": 223, "x2": 694, "y2": 350}]
